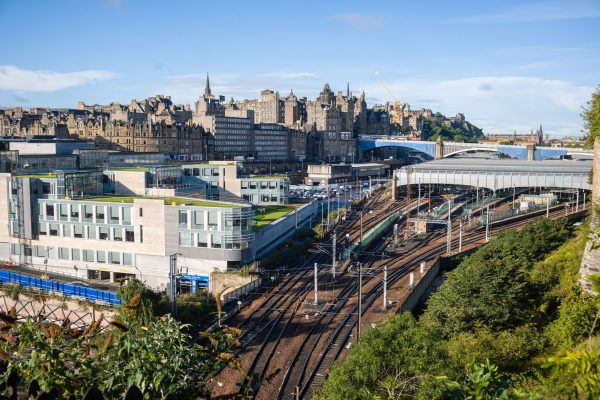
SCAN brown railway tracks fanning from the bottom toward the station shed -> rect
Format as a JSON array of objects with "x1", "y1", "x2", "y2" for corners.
[{"x1": 212, "y1": 191, "x2": 584, "y2": 399}]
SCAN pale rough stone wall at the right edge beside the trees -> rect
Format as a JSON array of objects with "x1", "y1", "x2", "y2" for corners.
[{"x1": 579, "y1": 139, "x2": 600, "y2": 294}]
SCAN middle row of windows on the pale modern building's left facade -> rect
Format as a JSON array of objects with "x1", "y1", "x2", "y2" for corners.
[{"x1": 39, "y1": 222, "x2": 135, "y2": 242}]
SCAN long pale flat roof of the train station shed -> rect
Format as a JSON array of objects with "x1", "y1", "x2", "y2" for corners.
[{"x1": 402, "y1": 158, "x2": 592, "y2": 174}]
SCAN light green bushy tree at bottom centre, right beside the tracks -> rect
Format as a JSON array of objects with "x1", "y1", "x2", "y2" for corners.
[{"x1": 315, "y1": 313, "x2": 446, "y2": 400}]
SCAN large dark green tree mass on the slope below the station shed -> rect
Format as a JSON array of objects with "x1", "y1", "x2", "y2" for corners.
[{"x1": 420, "y1": 219, "x2": 570, "y2": 339}]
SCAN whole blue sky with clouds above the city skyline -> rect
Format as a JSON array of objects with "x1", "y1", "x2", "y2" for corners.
[{"x1": 0, "y1": 0, "x2": 600, "y2": 137}]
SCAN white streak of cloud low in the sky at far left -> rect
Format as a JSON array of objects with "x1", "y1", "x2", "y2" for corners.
[{"x1": 0, "y1": 65, "x2": 116, "y2": 92}]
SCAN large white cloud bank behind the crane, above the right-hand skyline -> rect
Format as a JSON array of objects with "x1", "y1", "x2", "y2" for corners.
[{"x1": 365, "y1": 76, "x2": 594, "y2": 137}]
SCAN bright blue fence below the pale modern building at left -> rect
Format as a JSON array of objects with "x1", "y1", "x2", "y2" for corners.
[{"x1": 0, "y1": 271, "x2": 121, "y2": 305}]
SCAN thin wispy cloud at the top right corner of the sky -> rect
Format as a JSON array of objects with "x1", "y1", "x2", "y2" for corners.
[{"x1": 448, "y1": 0, "x2": 600, "y2": 24}]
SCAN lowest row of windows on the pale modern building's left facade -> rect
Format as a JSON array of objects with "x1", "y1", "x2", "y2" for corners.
[{"x1": 10, "y1": 243, "x2": 133, "y2": 265}]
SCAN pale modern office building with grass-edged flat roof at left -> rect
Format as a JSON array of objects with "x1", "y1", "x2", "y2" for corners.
[{"x1": 0, "y1": 171, "x2": 254, "y2": 288}]
